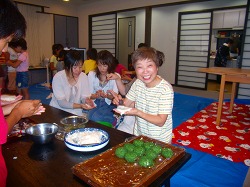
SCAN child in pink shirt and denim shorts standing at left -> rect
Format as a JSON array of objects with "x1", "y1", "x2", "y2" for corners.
[{"x1": 8, "y1": 38, "x2": 30, "y2": 100}]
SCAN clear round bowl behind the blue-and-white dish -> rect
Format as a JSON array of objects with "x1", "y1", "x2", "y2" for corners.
[{"x1": 60, "y1": 115, "x2": 88, "y2": 132}]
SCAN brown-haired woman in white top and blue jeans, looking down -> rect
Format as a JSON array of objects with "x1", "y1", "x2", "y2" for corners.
[{"x1": 88, "y1": 50, "x2": 118, "y2": 124}]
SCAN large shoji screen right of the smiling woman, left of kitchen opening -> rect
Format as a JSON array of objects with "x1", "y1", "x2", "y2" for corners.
[{"x1": 176, "y1": 12, "x2": 211, "y2": 88}]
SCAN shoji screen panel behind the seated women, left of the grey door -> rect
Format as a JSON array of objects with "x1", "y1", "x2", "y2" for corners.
[{"x1": 90, "y1": 14, "x2": 116, "y2": 56}]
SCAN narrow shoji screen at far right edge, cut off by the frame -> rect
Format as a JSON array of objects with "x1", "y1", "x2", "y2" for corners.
[{"x1": 238, "y1": 2, "x2": 250, "y2": 99}]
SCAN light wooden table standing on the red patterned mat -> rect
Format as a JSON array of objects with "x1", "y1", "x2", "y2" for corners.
[{"x1": 198, "y1": 67, "x2": 250, "y2": 125}]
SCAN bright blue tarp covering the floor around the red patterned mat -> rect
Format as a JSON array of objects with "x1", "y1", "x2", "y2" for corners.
[{"x1": 29, "y1": 84, "x2": 250, "y2": 187}]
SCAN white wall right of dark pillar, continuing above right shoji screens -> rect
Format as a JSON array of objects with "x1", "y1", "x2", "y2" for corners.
[{"x1": 151, "y1": 0, "x2": 247, "y2": 84}]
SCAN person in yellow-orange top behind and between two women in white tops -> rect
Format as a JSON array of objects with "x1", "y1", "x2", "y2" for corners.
[{"x1": 82, "y1": 48, "x2": 97, "y2": 75}]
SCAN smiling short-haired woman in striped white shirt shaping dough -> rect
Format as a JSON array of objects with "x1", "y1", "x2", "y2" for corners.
[{"x1": 113, "y1": 47, "x2": 174, "y2": 143}]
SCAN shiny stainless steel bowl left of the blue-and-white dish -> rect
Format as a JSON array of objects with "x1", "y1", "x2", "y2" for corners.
[{"x1": 25, "y1": 123, "x2": 58, "y2": 144}]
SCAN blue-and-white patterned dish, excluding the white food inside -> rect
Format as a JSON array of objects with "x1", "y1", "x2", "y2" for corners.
[{"x1": 64, "y1": 128, "x2": 109, "y2": 152}]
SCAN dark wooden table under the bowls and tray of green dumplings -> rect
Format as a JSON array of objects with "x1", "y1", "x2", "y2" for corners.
[{"x1": 2, "y1": 105, "x2": 191, "y2": 187}]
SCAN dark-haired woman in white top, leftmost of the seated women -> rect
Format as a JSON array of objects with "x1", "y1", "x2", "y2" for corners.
[{"x1": 50, "y1": 50, "x2": 94, "y2": 116}]
